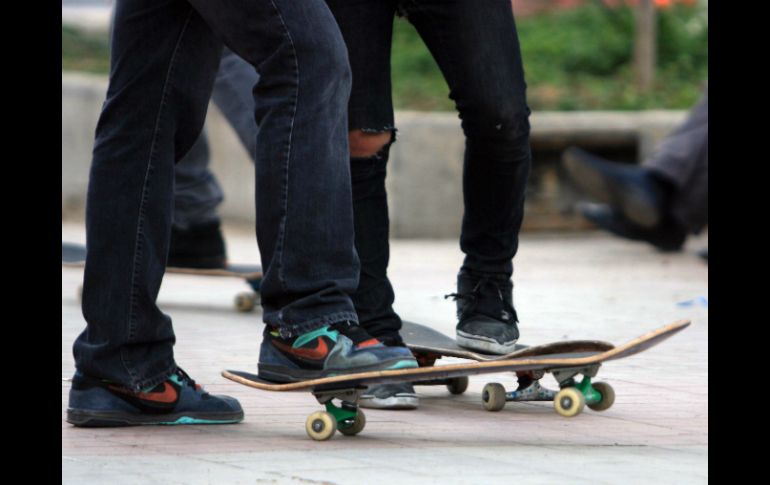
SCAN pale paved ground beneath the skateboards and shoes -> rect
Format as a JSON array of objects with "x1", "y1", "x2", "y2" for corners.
[{"x1": 62, "y1": 224, "x2": 708, "y2": 485}]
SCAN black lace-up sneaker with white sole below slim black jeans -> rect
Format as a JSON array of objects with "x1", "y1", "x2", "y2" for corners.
[{"x1": 446, "y1": 270, "x2": 519, "y2": 355}]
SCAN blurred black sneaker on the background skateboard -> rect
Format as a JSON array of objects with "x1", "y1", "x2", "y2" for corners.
[{"x1": 167, "y1": 221, "x2": 227, "y2": 269}]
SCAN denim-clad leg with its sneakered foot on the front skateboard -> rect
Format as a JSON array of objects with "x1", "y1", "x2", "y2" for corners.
[{"x1": 184, "y1": 0, "x2": 416, "y2": 380}]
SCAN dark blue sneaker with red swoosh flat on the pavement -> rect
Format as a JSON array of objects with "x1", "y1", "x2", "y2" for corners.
[{"x1": 67, "y1": 368, "x2": 243, "y2": 427}]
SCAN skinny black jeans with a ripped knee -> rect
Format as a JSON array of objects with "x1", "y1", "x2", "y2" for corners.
[{"x1": 327, "y1": 0, "x2": 531, "y2": 343}]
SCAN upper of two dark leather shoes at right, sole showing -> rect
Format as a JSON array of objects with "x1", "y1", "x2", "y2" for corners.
[{"x1": 562, "y1": 147, "x2": 666, "y2": 229}]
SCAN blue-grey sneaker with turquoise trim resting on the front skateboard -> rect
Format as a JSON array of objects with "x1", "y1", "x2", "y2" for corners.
[{"x1": 259, "y1": 322, "x2": 417, "y2": 382}]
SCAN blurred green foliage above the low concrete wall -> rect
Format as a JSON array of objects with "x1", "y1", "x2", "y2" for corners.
[{"x1": 62, "y1": 0, "x2": 708, "y2": 110}]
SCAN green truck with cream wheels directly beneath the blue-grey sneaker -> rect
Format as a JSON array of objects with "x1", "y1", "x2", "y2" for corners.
[{"x1": 305, "y1": 387, "x2": 366, "y2": 441}]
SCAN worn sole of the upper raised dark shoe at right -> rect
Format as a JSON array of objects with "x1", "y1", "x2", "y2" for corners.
[{"x1": 564, "y1": 156, "x2": 660, "y2": 229}]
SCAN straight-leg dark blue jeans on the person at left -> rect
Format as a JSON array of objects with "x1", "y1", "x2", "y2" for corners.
[{"x1": 74, "y1": 0, "x2": 359, "y2": 389}]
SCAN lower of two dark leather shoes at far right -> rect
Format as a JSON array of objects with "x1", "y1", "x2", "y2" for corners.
[{"x1": 578, "y1": 203, "x2": 687, "y2": 251}]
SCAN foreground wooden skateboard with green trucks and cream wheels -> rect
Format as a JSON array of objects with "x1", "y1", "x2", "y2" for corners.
[{"x1": 222, "y1": 320, "x2": 690, "y2": 441}]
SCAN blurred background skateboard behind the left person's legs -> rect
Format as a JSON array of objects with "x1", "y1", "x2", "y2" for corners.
[{"x1": 61, "y1": 241, "x2": 262, "y2": 312}]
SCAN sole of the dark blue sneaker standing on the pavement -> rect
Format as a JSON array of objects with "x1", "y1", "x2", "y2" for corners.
[{"x1": 67, "y1": 409, "x2": 243, "y2": 428}]
